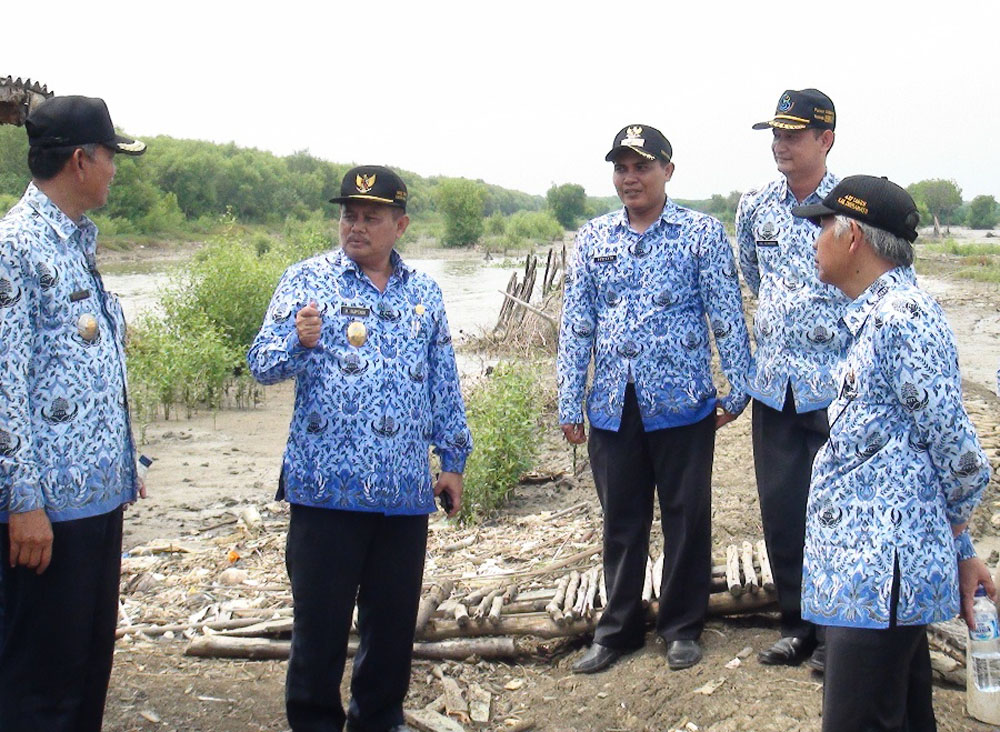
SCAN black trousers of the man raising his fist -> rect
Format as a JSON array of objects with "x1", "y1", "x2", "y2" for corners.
[{"x1": 285, "y1": 504, "x2": 427, "y2": 732}]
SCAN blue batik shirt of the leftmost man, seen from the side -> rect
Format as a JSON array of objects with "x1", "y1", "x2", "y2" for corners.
[{"x1": 0, "y1": 183, "x2": 137, "y2": 522}]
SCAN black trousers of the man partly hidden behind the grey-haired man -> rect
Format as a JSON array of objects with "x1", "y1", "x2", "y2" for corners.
[{"x1": 752, "y1": 386, "x2": 830, "y2": 638}]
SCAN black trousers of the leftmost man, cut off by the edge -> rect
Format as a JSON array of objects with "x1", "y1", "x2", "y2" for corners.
[{"x1": 0, "y1": 508, "x2": 122, "y2": 732}]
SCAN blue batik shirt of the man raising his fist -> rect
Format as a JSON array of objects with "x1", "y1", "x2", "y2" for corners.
[{"x1": 247, "y1": 249, "x2": 472, "y2": 515}]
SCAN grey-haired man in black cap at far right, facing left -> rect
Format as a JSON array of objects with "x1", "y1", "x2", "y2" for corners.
[{"x1": 792, "y1": 175, "x2": 996, "y2": 732}]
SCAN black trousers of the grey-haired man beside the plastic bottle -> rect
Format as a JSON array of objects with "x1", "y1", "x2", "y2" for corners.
[{"x1": 823, "y1": 564, "x2": 937, "y2": 732}]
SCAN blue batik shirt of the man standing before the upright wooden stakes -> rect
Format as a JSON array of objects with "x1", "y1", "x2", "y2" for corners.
[{"x1": 557, "y1": 199, "x2": 750, "y2": 431}]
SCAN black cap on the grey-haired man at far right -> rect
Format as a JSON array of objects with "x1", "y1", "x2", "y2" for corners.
[{"x1": 792, "y1": 175, "x2": 920, "y2": 244}]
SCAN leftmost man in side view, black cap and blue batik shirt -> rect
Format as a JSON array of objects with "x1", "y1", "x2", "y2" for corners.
[{"x1": 0, "y1": 96, "x2": 146, "y2": 732}]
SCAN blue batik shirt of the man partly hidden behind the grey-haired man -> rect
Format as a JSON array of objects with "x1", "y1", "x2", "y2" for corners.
[{"x1": 736, "y1": 172, "x2": 850, "y2": 412}]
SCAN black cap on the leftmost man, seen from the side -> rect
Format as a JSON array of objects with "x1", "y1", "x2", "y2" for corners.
[{"x1": 24, "y1": 96, "x2": 146, "y2": 155}]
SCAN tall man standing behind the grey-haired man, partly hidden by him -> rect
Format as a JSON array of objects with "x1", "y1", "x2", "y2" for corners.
[{"x1": 736, "y1": 89, "x2": 850, "y2": 671}]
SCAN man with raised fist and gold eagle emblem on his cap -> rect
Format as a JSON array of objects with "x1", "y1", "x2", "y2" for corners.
[{"x1": 247, "y1": 165, "x2": 472, "y2": 732}]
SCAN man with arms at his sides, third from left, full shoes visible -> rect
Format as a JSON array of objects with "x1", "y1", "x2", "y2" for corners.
[{"x1": 557, "y1": 125, "x2": 750, "y2": 673}]
